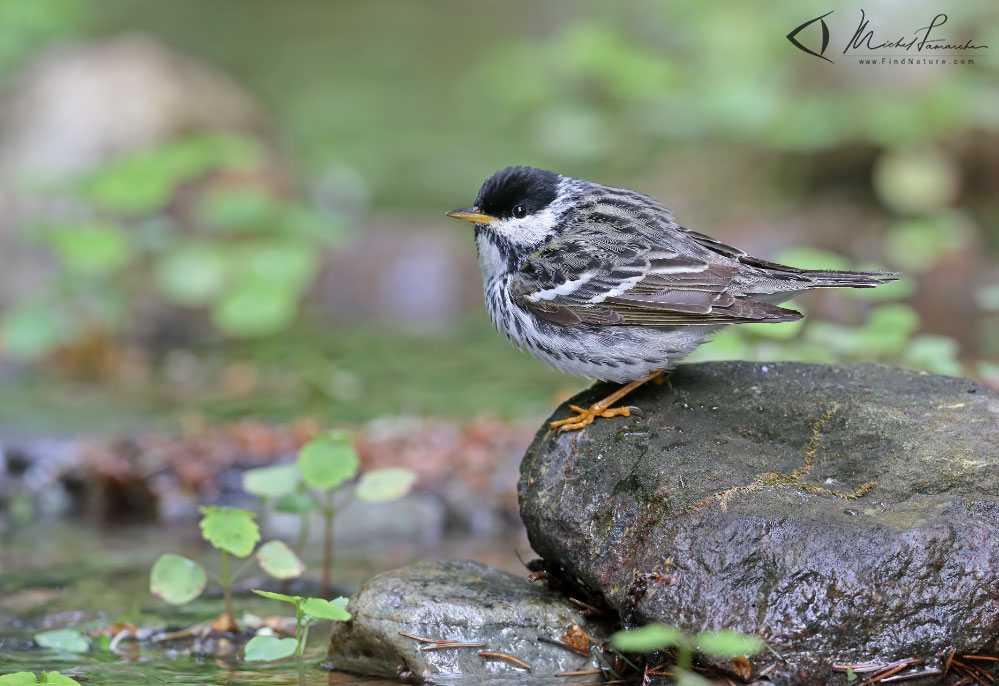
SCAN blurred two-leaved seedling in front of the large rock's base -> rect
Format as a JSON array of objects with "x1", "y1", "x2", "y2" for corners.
[{"x1": 610, "y1": 623, "x2": 764, "y2": 686}]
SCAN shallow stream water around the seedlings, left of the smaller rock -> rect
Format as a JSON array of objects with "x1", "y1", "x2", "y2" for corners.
[{"x1": 0, "y1": 524, "x2": 548, "y2": 686}]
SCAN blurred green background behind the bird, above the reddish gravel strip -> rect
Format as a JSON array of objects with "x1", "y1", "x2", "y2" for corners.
[{"x1": 0, "y1": 0, "x2": 999, "y2": 426}]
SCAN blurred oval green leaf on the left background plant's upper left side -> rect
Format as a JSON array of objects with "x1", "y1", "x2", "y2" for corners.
[{"x1": 43, "y1": 224, "x2": 131, "y2": 275}]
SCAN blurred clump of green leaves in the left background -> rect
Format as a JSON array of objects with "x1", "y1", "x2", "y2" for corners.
[{"x1": 0, "y1": 133, "x2": 342, "y2": 360}]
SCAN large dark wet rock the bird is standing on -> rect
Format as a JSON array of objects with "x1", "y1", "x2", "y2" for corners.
[{"x1": 520, "y1": 362, "x2": 999, "y2": 683}]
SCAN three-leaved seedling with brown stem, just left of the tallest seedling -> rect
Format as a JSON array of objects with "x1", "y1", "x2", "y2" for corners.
[{"x1": 149, "y1": 506, "x2": 305, "y2": 628}]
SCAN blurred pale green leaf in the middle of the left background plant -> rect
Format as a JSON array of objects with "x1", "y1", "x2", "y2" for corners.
[{"x1": 156, "y1": 243, "x2": 230, "y2": 307}]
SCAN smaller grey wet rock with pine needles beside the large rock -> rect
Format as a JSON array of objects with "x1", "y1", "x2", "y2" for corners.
[{"x1": 329, "y1": 561, "x2": 606, "y2": 684}]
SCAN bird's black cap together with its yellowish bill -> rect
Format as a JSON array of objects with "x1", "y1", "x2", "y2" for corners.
[{"x1": 446, "y1": 167, "x2": 559, "y2": 224}]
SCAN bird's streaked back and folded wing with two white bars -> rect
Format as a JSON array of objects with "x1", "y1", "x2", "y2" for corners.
[{"x1": 510, "y1": 196, "x2": 801, "y2": 327}]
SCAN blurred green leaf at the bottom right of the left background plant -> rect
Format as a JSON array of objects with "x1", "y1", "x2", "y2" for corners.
[{"x1": 212, "y1": 280, "x2": 301, "y2": 338}]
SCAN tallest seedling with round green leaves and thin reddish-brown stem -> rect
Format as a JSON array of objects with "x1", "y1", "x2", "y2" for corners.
[{"x1": 243, "y1": 431, "x2": 416, "y2": 592}]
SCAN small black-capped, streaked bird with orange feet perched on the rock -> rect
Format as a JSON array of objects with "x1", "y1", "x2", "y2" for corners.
[{"x1": 445, "y1": 166, "x2": 897, "y2": 432}]
